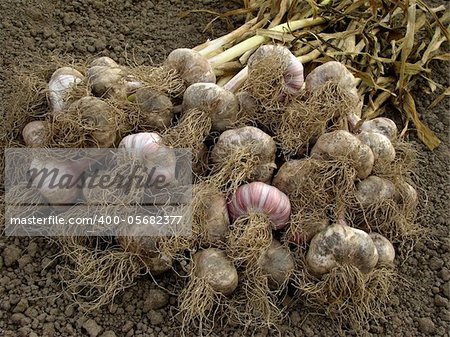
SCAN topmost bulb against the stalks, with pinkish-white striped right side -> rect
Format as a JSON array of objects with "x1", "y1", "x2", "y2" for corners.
[{"x1": 248, "y1": 45, "x2": 304, "y2": 98}]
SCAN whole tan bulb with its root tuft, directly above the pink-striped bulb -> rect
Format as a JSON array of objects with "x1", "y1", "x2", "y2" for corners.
[{"x1": 210, "y1": 126, "x2": 276, "y2": 191}]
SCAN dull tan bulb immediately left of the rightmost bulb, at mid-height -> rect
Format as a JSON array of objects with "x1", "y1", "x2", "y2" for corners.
[{"x1": 356, "y1": 176, "x2": 395, "y2": 206}]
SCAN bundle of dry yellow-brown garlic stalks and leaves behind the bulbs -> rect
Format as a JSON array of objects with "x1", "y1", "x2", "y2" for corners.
[{"x1": 194, "y1": 0, "x2": 450, "y2": 149}]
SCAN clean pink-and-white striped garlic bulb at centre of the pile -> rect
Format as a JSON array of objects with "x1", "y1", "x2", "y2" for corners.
[{"x1": 228, "y1": 181, "x2": 291, "y2": 229}]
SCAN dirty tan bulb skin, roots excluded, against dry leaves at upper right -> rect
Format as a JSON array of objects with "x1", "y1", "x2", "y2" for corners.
[{"x1": 305, "y1": 61, "x2": 363, "y2": 117}]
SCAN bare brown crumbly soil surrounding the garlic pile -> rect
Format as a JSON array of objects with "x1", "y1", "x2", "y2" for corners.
[{"x1": 0, "y1": 0, "x2": 450, "y2": 337}]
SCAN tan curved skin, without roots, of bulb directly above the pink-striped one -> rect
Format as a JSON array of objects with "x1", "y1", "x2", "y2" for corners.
[{"x1": 211, "y1": 126, "x2": 276, "y2": 183}]
